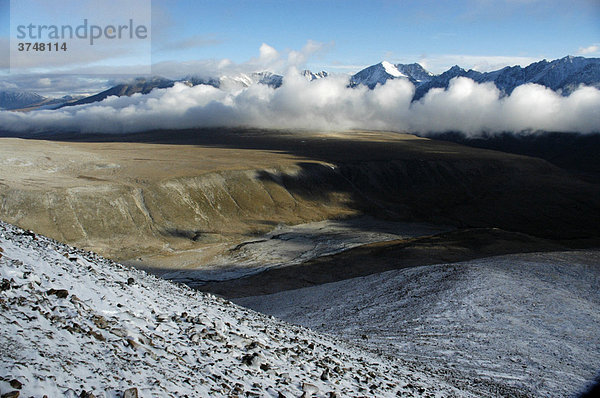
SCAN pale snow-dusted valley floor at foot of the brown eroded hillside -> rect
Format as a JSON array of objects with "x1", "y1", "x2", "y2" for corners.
[{"x1": 157, "y1": 216, "x2": 450, "y2": 286}]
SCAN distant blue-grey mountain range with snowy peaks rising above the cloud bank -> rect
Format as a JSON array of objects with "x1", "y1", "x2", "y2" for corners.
[{"x1": 0, "y1": 56, "x2": 600, "y2": 110}]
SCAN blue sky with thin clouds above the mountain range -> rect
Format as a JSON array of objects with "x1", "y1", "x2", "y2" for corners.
[{"x1": 0, "y1": 0, "x2": 600, "y2": 90}]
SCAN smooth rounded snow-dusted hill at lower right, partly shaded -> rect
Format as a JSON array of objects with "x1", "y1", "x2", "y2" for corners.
[{"x1": 236, "y1": 251, "x2": 600, "y2": 397}]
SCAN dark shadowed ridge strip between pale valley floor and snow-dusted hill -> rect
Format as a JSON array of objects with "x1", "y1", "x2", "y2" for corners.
[{"x1": 194, "y1": 229, "x2": 576, "y2": 299}]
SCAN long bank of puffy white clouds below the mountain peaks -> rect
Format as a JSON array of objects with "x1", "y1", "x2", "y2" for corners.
[{"x1": 0, "y1": 72, "x2": 600, "y2": 134}]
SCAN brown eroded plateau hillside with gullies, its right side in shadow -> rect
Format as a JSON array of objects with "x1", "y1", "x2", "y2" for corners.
[{"x1": 0, "y1": 130, "x2": 600, "y2": 268}]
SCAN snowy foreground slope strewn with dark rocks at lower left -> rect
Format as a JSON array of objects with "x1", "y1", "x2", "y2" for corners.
[{"x1": 0, "y1": 222, "x2": 474, "y2": 398}]
